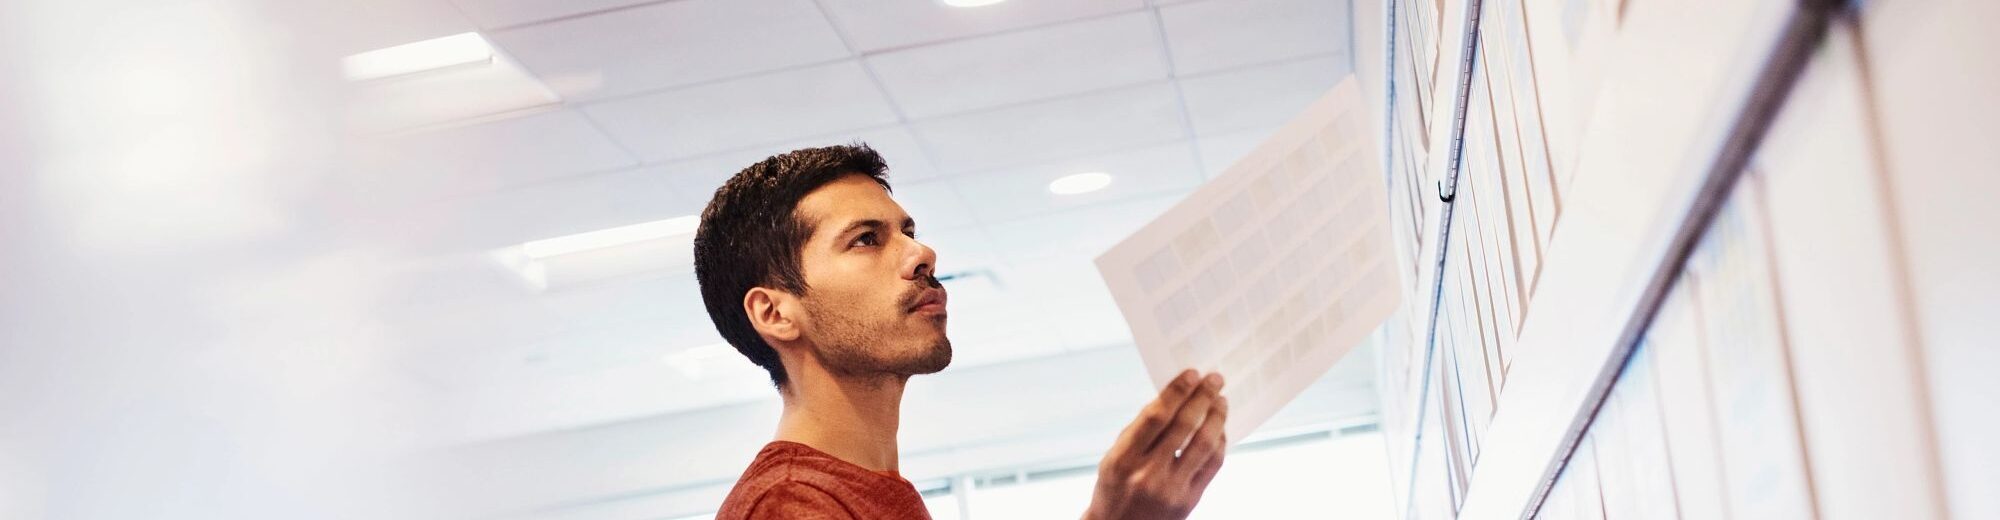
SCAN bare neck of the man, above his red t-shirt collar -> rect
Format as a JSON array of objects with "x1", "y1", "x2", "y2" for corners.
[{"x1": 778, "y1": 372, "x2": 906, "y2": 472}]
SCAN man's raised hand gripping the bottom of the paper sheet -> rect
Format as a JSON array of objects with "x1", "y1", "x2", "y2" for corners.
[{"x1": 1084, "y1": 370, "x2": 1230, "y2": 520}]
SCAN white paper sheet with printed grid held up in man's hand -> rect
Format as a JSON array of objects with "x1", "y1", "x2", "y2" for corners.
[{"x1": 1098, "y1": 78, "x2": 1402, "y2": 440}]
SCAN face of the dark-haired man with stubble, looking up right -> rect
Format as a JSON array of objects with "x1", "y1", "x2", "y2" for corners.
[{"x1": 796, "y1": 174, "x2": 952, "y2": 376}]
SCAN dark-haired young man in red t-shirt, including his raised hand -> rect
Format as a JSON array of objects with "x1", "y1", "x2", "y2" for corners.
[{"x1": 694, "y1": 144, "x2": 1228, "y2": 520}]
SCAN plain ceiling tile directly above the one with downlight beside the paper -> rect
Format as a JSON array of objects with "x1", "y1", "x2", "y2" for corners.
[{"x1": 910, "y1": 82, "x2": 1186, "y2": 174}]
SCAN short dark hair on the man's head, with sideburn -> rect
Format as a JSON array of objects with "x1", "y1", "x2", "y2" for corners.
[{"x1": 694, "y1": 142, "x2": 890, "y2": 388}]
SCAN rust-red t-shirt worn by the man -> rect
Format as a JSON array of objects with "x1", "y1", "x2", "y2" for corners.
[{"x1": 716, "y1": 440, "x2": 930, "y2": 520}]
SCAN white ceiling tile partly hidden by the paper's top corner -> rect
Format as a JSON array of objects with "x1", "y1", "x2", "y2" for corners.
[{"x1": 1180, "y1": 52, "x2": 1350, "y2": 136}]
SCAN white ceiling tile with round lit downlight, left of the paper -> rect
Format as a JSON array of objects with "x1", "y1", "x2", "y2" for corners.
[{"x1": 950, "y1": 142, "x2": 1202, "y2": 224}]
